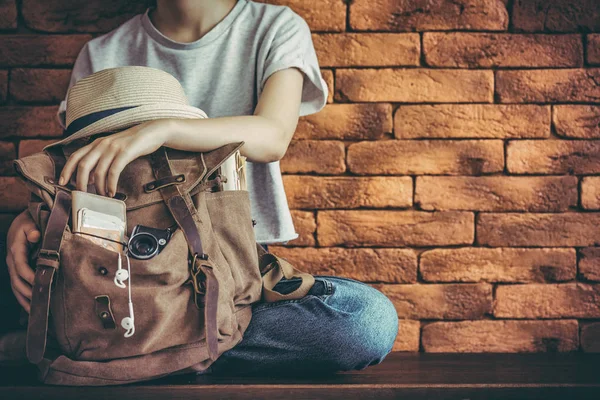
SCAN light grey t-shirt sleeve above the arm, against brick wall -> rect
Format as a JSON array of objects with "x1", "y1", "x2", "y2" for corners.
[{"x1": 259, "y1": 7, "x2": 328, "y2": 116}]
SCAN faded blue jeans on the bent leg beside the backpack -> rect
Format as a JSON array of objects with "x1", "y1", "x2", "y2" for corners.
[{"x1": 200, "y1": 244, "x2": 399, "y2": 375}]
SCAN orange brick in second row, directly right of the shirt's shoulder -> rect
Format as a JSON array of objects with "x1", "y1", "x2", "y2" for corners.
[{"x1": 313, "y1": 33, "x2": 421, "y2": 67}]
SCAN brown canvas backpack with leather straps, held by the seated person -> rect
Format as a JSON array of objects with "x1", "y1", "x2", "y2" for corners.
[{"x1": 0, "y1": 137, "x2": 314, "y2": 385}]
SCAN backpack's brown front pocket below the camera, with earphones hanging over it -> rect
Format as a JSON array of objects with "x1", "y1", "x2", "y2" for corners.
[{"x1": 51, "y1": 231, "x2": 209, "y2": 360}]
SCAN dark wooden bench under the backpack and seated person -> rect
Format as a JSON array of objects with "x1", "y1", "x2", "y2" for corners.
[{"x1": 0, "y1": 353, "x2": 600, "y2": 400}]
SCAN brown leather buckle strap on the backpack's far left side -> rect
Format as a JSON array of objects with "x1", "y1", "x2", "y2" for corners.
[{"x1": 26, "y1": 188, "x2": 71, "y2": 364}]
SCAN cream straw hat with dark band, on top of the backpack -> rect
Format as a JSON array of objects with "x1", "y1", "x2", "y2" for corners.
[{"x1": 51, "y1": 66, "x2": 207, "y2": 146}]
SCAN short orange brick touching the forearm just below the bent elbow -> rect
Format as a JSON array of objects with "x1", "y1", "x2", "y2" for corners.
[{"x1": 280, "y1": 140, "x2": 346, "y2": 174}]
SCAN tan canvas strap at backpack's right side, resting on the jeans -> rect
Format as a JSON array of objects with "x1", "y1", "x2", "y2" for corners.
[{"x1": 256, "y1": 242, "x2": 315, "y2": 303}]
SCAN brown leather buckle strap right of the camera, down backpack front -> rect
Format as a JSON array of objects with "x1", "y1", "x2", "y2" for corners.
[{"x1": 150, "y1": 147, "x2": 219, "y2": 360}]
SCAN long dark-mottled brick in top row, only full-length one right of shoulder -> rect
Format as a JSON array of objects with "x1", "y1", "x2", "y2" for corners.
[{"x1": 350, "y1": 0, "x2": 508, "y2": 31}]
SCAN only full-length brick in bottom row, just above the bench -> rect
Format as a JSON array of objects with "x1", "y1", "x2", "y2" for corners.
[{"x1": 422, "y1": 320, "x2": 579, "y2": 353}]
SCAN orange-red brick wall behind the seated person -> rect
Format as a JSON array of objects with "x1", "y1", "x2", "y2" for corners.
[{"x1": 0, "y1": 0, "x2": 600, "y2": 352}]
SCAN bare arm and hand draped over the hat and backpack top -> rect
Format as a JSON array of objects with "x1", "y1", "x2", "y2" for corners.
[{"x1": 59, "y1": 68, "x2": 303, "y2": 197}]
